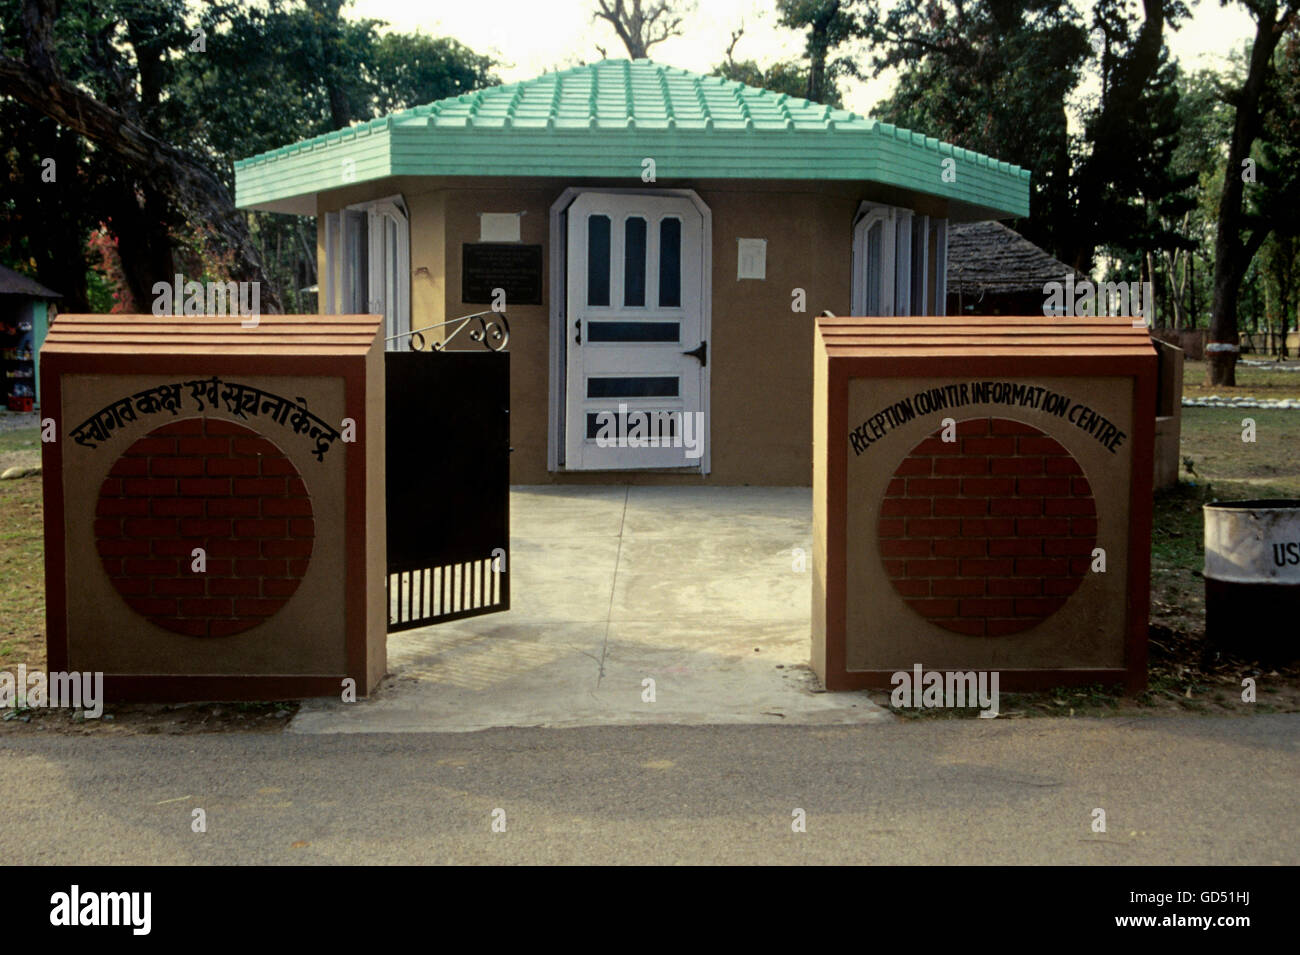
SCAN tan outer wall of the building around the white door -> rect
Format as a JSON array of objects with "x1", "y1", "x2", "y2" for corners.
[{"x1": 317, "y1": 178, "x2": 948, "y2": 485}]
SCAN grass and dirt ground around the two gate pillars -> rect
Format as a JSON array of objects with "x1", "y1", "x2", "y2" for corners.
[{"x1": 0, "y1": 361, "x2": 1300, "y2": 734}]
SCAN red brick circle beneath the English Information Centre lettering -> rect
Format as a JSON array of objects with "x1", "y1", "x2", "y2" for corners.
[{"x1": 876, "y1": 418, "x2": 1097, "y2": 637}]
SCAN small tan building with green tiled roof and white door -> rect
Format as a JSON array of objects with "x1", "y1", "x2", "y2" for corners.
[{"x1": 235, "y1": 60, "x2": 1030, "y2": 485}]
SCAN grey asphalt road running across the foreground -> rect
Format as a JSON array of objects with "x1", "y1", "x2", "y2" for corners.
[{"x1": 0, "y1": 715, "x2": 1300, "y2": 865}]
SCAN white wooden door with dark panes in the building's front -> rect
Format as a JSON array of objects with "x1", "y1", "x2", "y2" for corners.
[{"x1": 564, "y1": 192, "x2": 710, "y2": 470}]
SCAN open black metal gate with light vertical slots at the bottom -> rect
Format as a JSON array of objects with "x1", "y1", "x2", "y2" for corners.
[{"x1": 385, "y1": 351, "x2": 510, "y2": 631}]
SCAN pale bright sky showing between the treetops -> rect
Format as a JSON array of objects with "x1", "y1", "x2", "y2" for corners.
[{"x1": 350, "y1": 0, "x2": 1253, "y2": 116}]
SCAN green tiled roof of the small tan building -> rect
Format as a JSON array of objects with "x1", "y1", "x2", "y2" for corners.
[{"x1": 235, "y1": 60, "x2": 1030, "y2": 216}]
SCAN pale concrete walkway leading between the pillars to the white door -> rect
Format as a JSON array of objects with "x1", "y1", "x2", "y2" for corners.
[{"x1": 290, "y1": 486, "x2": 892, "y2": 733}]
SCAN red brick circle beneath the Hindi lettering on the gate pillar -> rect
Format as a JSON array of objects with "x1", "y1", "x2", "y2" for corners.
[{"x1": 95, "y1": 418, "x2": 316, "y2": 637}]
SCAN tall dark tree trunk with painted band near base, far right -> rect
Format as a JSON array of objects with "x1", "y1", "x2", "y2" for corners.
[{"x1": 1206, "y1": 0, "x2": 1296, "y2": 386}]
